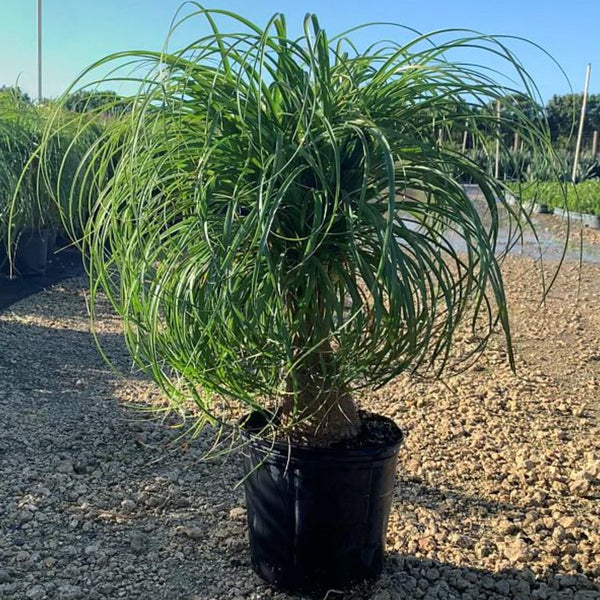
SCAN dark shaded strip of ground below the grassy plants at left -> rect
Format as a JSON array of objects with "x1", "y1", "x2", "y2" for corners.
[{"x1": 0, "y1": 248, "x2": 84, "y2": 311}]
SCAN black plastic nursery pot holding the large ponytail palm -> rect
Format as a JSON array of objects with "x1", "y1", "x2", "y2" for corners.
[{"x1": 244, "y1": 413, "x2": 402, "y2": 592}]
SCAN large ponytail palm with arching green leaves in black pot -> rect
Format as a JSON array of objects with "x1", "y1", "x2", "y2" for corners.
[{"x1": 44, "y1": 9, "x2": 548, "y2": 589}]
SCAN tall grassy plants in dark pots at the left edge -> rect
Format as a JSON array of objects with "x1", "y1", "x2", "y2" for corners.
[{"x1": 0, "y1": 91, "x2": 99, "y2": 275}]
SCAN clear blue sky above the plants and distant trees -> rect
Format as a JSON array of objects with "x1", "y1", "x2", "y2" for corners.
[{"x1": 0, "y1": 0, "x2": 600, "y2": 99}]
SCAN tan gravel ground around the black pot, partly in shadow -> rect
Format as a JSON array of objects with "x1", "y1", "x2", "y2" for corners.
[{"x1": 0, "y1": 250, "x2": 600, "y2": 600}]
